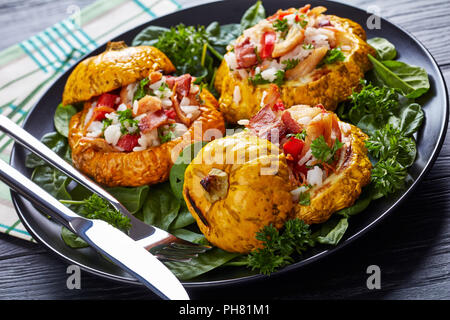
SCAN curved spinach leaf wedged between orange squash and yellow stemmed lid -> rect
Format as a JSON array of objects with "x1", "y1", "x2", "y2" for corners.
[{"x1": 169, "y1": 141, "x2": 207, "y2": 200}]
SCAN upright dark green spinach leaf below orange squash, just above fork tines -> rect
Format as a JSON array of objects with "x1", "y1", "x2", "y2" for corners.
[{"x1": 142, "y1": 182, "x2": 180, "y2": 231}]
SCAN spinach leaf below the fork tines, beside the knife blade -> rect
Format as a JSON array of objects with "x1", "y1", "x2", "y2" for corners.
[{"x1": 164, "y1": 248, "x2": 240, "y2": 280}]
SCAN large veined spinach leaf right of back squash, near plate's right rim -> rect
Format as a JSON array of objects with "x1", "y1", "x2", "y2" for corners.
[{"x1": 368, "y1": 54, "x2": 430, "y2": 99}]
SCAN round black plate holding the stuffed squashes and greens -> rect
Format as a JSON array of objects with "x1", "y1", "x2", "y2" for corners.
[{"x1": 11, "y1": 0, "x2": 448, "y2": 287}]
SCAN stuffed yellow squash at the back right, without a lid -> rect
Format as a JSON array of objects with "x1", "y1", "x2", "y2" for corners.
[{"x1": 215, "y1": 6, "x2": 374, "y2": 123}]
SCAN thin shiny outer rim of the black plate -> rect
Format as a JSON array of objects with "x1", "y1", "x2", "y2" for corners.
[{"x1": 10, "y1": 0, "x2": 450, "y2": 288}]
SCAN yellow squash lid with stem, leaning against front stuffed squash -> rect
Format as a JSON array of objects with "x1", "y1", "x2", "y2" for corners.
[{"x1": 183, "y1": 133, "x2": 293, "y2": 253}]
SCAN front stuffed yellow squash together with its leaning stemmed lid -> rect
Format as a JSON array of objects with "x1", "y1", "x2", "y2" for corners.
[{"x1": 183, "y1": 100, "x2": 372, "y2": 253}]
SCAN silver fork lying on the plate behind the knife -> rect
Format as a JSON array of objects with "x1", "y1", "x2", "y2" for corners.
[{"x1": 0, "y1": 115, "x2": 211, "y2": 262}]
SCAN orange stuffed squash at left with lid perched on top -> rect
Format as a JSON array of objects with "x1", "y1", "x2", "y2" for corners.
[{"x1": 63, "y1": 43, "x2": 225, "y2": 187}]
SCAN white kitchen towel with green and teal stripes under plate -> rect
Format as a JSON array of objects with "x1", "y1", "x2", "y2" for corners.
[{"x1": 0, "y1": 0, "x2": 187, "y2": 240}]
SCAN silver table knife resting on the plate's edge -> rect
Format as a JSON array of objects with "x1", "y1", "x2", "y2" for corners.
[{"x1": 0, "y1": 160, "x2": 189, "y2": 300}]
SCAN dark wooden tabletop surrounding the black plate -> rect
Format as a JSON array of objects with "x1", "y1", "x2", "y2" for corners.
[{"x1": 0, "y1": 0, "x2": 450, "y2": 299}]
